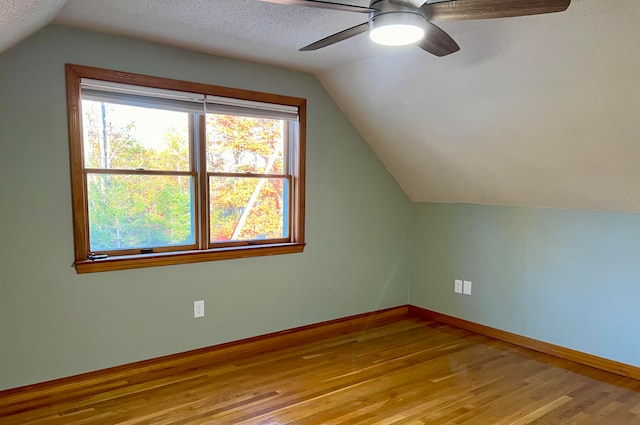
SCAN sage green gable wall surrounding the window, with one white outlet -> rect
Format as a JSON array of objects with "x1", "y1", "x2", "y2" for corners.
[{"x1": 0, "y1": 26, "x2": 412, "y2": 389}]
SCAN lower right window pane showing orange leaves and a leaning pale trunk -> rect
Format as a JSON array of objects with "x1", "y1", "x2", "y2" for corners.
[{"x1": 209, "y1": 176, "x2": 289, "y2": 242}]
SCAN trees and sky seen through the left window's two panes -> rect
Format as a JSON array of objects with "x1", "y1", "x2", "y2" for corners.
[{"x1": 83, "y1": 100, "x2": 194, "y2": 251}]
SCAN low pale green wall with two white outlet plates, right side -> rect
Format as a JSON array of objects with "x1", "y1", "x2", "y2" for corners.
[{"x1": 410, "y1": 203, "x2": 640, "y2": 366}]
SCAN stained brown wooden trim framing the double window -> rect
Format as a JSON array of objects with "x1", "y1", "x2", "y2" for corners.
[{"x1": 65, "y1": 64, "x2": 306, "y2": 273}]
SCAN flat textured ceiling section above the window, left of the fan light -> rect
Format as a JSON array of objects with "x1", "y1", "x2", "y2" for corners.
[{"x1": 56, "y1": 0, "x2": 371, "y2": 71}]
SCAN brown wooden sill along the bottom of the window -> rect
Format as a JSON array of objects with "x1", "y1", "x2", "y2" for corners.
[{"x1": 75, "y1": 243, "x2": 304, "y2": 274}]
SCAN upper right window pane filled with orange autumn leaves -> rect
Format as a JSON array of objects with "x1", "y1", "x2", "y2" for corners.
[{"x1": 207, "y1": 114, "x2": 286, "y2": 174}]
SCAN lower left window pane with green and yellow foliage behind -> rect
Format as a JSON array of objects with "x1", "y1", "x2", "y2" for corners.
[{"x1": 88, "y1": 174, "x2": 195, "y2": 251}]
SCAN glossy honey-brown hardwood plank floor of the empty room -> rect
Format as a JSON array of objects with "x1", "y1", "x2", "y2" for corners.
[{"x1": 0, "y1": 317, "x2": 640, "y2": 425}]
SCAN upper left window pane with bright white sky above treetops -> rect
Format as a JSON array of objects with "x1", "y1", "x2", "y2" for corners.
[{"x1": 82, "y1": 100, "x2": 190, "y2": 171}]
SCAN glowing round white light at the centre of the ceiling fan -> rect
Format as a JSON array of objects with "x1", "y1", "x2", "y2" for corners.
[{"x1": 369, "y1": 12, "x2": 426, "y2": 46}]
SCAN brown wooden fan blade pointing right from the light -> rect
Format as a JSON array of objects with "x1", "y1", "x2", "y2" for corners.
[{"x1": 421, "y1": 0, "x2": 571, "y2": 21}]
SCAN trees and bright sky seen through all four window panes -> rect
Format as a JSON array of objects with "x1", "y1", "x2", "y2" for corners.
[{"x1": 83, "y1": 100, "x2": 288, "y2": 251}]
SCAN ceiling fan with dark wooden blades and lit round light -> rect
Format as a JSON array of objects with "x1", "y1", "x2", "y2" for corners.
[{"x1": 260, "y1": 0, "x2": 571, "y2": 56}]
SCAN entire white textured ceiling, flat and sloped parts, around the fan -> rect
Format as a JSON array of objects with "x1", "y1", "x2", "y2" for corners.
[{"x1": 0, "y1": 0, "x2": 640, "y2": 212}]
